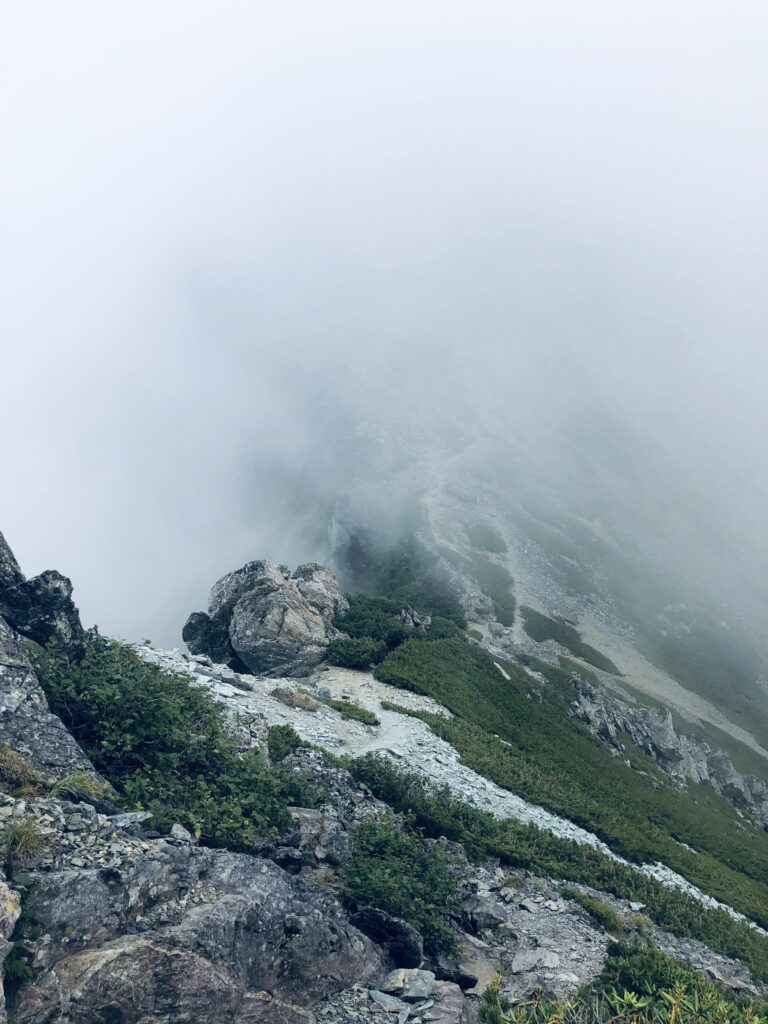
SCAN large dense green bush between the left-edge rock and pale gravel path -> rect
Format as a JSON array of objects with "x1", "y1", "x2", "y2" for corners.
[{"x1": 38, "y1": 632, "x2": 311, "y2": 850}]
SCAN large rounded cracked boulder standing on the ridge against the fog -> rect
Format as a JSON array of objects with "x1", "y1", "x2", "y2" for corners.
[{"x1": 182, "y1": 561, "x2": 347, "y2": 676}]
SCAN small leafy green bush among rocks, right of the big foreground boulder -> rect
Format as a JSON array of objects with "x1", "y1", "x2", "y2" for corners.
[{"x1": 343, "y1": 814, "x2": 459, "y2": 954}]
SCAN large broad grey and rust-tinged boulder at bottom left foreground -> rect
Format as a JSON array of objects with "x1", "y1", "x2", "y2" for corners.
[{"x1": 15, "y1": 841, "x2": 383, "y2": 1024}]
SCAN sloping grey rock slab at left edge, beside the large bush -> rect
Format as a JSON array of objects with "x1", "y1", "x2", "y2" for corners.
[{"x1": 0, "y1": 618, "x2": 96, "y2": 780}]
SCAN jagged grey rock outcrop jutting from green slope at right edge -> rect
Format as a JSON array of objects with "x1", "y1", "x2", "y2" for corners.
[{"x1": 570, "y1": 675, "x2": 768, "y2": 825}]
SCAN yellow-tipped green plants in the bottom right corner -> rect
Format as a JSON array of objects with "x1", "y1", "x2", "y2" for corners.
[{"x1": 480, "y1": 942, "x2": 768, "y2": 1024}]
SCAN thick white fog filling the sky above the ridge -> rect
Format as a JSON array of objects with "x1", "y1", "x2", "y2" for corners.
[{"x1": 0, "y1": 0, "x2": 768, "y2": 643}]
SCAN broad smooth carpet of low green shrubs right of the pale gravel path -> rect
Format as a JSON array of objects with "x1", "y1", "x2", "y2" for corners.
[{"x1": 375, "y1": 639, "x2": 768, "y2": 927}]
